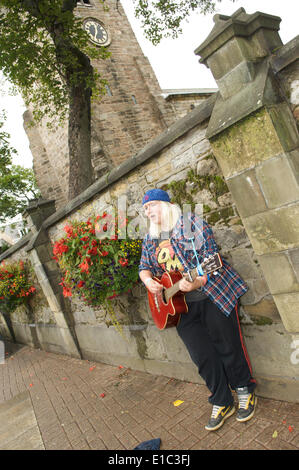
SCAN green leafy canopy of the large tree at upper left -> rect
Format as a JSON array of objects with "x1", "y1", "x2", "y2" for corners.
[{"x1": 0, "y1": 0, "x2": 109, "y2": 122}]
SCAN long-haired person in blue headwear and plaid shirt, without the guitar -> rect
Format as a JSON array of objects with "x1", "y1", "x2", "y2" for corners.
[{"x1": 139, "y1": 189, "x2": 257, "y2": 431}]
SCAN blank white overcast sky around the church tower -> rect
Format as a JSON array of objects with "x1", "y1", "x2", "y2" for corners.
[{"x1": 0, "y1": 0, "x2": 299, "y2": 168}]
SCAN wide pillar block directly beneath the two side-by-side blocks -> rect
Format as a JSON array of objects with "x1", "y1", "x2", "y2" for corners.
[{"x1": 243, "y1": 204, "x2": 299, "y2": 255}]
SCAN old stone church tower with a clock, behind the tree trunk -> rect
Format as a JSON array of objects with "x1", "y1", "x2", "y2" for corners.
[{"x1": 24, "y1": 0, "x2": 176, "y2": 209}]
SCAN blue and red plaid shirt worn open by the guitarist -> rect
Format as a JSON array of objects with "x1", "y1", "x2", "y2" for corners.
[{"x1": 139, "y1": 214, "x2": 248, "y2": 316}]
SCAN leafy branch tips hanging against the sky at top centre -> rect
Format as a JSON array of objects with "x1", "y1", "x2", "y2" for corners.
[{"x1": 133, "y1": 0, "x2": 230, "y2": 45}]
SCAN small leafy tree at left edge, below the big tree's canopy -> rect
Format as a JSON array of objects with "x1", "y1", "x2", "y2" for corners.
[{"x1": 0, "y1": 115, "x2": 40, "y2": 223}]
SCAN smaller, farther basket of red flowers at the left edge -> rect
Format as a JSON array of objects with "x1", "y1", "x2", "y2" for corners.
[{"x1": 0, "y1": 261, "x2": 36, "y2": 313}]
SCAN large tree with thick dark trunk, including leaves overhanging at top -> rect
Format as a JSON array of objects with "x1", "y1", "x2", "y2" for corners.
[{"x1": 0, "y1": 0, "x2": 220, "y2": 199}]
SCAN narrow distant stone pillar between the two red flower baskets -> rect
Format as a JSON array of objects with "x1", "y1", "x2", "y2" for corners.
[{"x1": 23, "y1": 199, "x2": 81, "y2": 358}]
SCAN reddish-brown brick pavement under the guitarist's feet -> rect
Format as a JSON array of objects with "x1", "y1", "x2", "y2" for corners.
[{"x1": 0, "y1": 343, "x2": 299, "y2": 450}]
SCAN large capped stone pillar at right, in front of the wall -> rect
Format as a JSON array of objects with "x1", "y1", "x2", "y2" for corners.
[{"x1": 195, "y1": 8, "x2": 299, "y2": 334}]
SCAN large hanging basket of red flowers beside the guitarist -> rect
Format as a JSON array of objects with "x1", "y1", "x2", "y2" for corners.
[{"x1": 53, "y1": 213, "x2": 142, "y2": 306}]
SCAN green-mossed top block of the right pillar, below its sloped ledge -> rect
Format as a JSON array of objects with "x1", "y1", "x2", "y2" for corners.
[{"x1": 211, "y1": 108, "x2": 283, "y2": 178}]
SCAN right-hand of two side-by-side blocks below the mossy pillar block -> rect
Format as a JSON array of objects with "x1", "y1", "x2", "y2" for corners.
[{"x1": 256, "y1": 155, "x2": 299, "y2": 209}]
